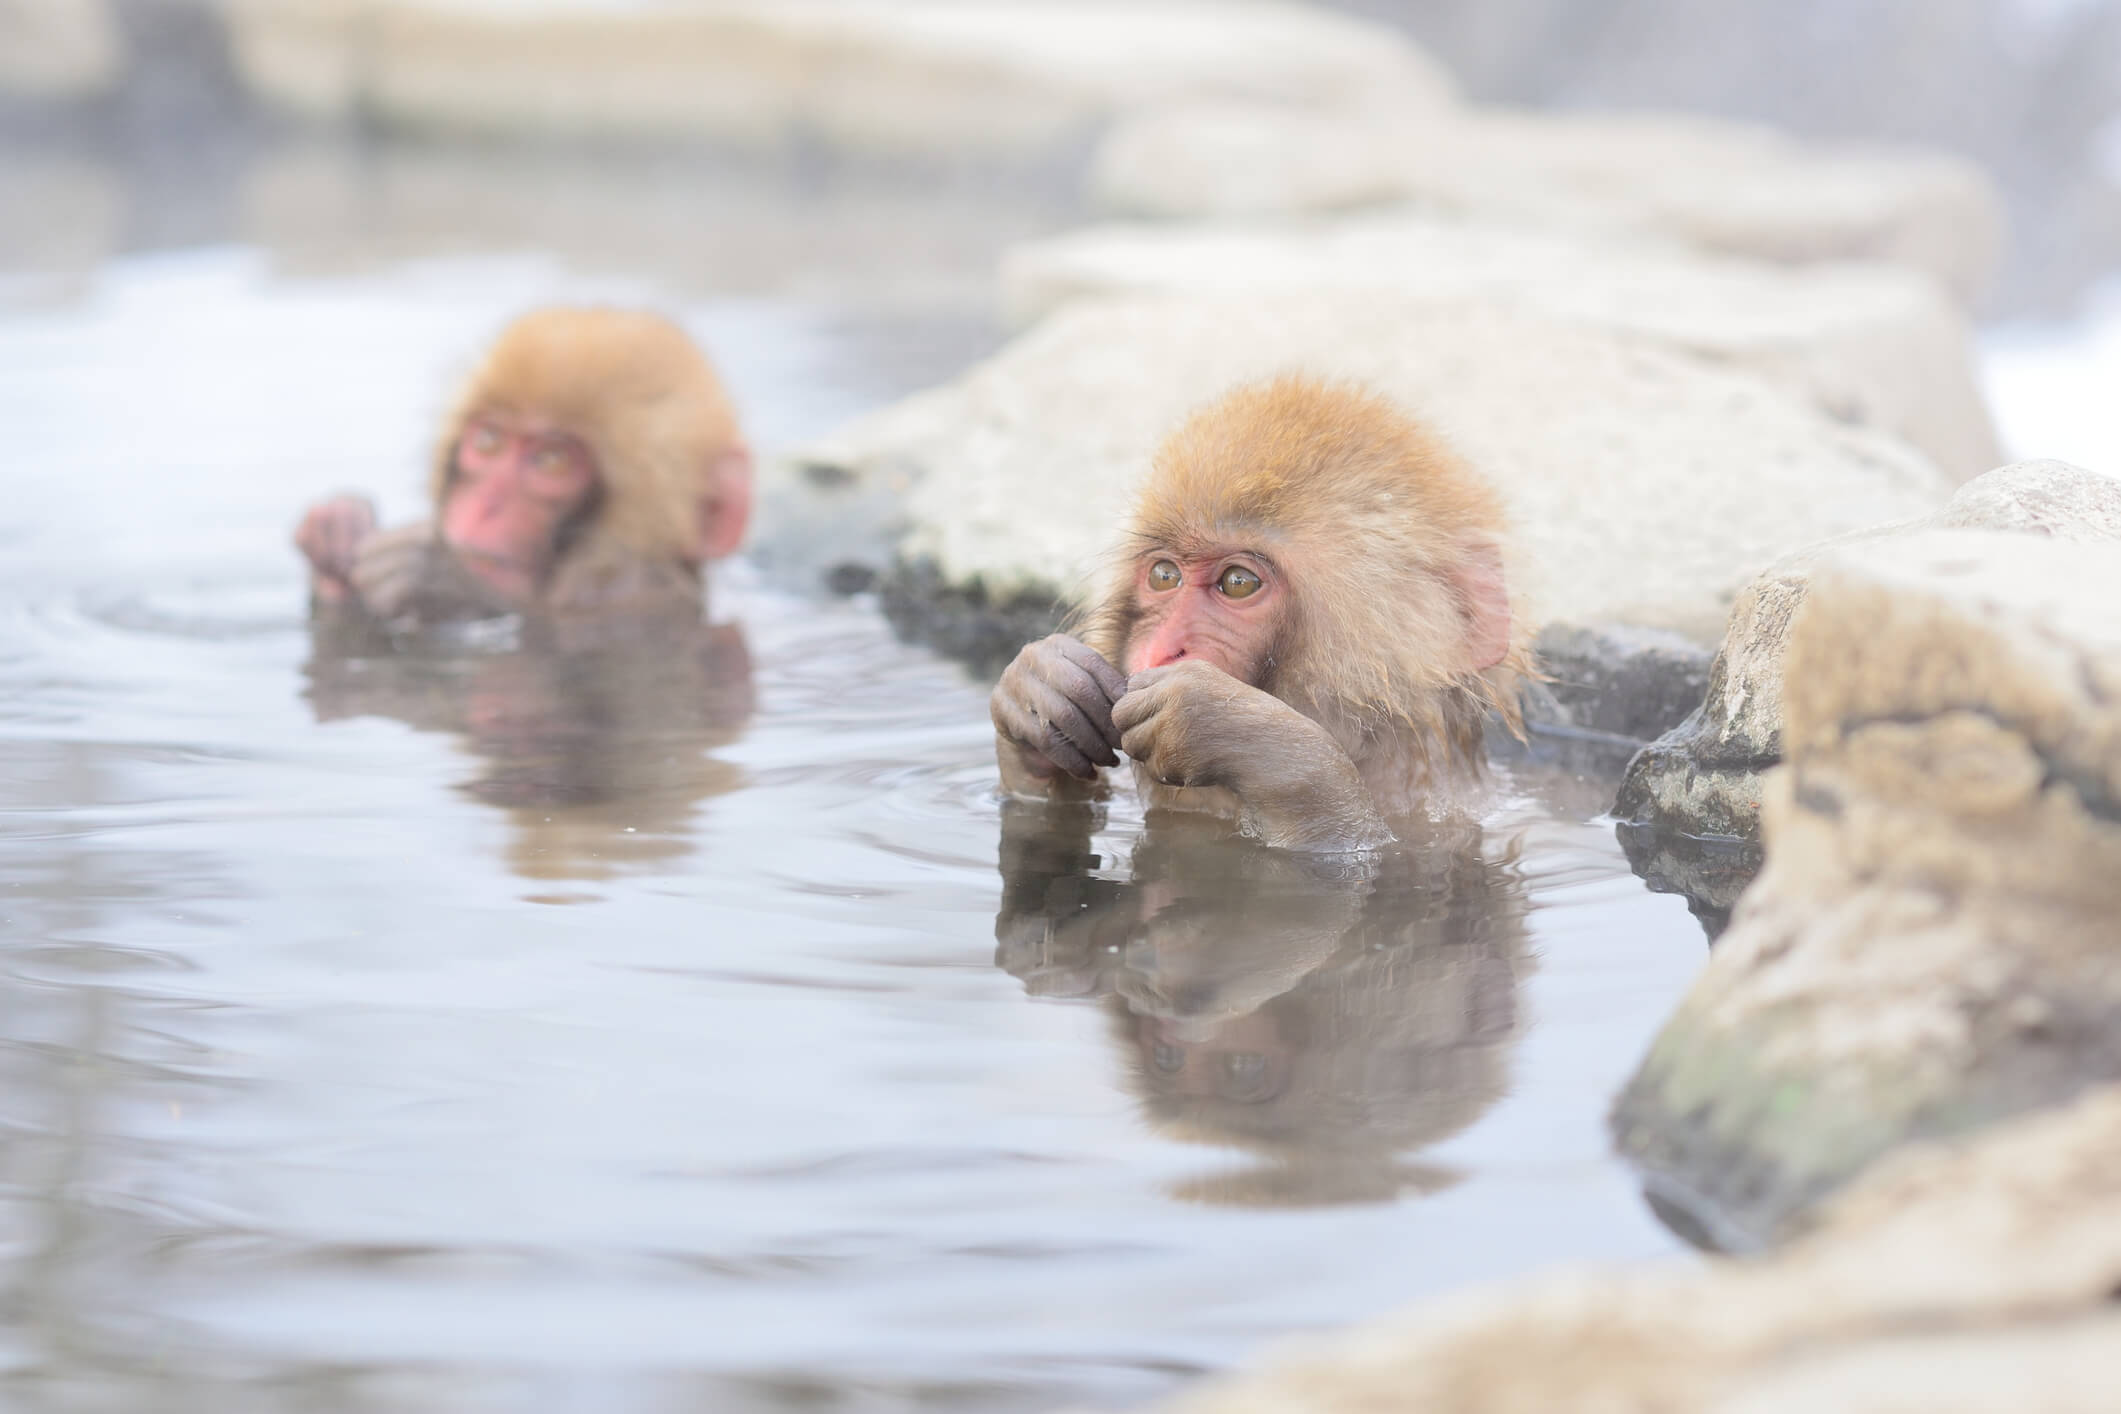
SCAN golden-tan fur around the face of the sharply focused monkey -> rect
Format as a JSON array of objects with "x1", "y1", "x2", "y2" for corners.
[{"x1": 1080, "y1": 377, "x2": 1533, "y2": 784}]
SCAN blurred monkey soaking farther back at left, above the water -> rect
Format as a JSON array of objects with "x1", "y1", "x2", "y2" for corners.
[{"x1": 295, "y1": 307, "x2": 751, "y2": 625}]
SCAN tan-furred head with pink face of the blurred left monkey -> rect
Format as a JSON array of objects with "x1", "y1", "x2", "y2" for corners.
[{"x1": 433, "y1": 307, "x2": 751, "y2": 598}]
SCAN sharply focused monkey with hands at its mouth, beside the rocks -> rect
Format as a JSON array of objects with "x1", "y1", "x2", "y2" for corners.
[{"x1": 991, "y1": 377, "x2": 1533, "y2": 850}]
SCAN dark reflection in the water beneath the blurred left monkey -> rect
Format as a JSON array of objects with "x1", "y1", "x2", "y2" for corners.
[{"x1": 305, "y1": 623, "x2": 751, "y2": 880}]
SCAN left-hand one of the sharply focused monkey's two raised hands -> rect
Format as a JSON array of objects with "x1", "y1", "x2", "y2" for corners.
[{"x1": 986, "y1": 634, "x2": 1126, "y2": 795}]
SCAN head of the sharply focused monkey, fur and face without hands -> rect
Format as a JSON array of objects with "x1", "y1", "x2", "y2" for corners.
[{"x1": 1084, "y1": 377, "x2": 1529, "y2": 750}]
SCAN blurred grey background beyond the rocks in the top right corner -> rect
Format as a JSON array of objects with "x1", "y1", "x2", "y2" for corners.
[{"x1": 1343, "y1": 0, "x2": 2121, "y2": 316}]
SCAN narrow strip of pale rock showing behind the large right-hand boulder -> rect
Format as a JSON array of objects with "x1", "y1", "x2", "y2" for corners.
[{"x1": 1614, "y1": 462, "x2": 2121, "y2": 839}]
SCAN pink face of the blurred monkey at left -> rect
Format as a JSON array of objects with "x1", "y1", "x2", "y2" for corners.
[{"x1": 441, "y1": 413, "x2": 598, "y2": 596}]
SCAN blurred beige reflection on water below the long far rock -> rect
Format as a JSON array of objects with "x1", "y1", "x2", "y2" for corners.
[{"x1": 238, "y1": 138, "x2": 1071, "y2": 309}]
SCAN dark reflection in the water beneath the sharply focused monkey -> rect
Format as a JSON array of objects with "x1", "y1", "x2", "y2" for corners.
[{"x1": 995, "y1": 801, "x2": 1527, "y2": 1206}]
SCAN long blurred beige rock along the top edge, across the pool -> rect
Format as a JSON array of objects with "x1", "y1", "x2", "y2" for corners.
[{"x1": 229, "y1": 0, "x2": 1451, "y2": 159}]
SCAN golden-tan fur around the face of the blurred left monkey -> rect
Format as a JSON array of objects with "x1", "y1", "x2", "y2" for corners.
[{"x1": 433, "y1": 307, "x2": 742, "y2": 564}]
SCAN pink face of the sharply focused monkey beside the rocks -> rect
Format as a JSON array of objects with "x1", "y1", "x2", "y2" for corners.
[{"x1": 1120, "y1": 551, "x2": 1290, "y2": 687}]
